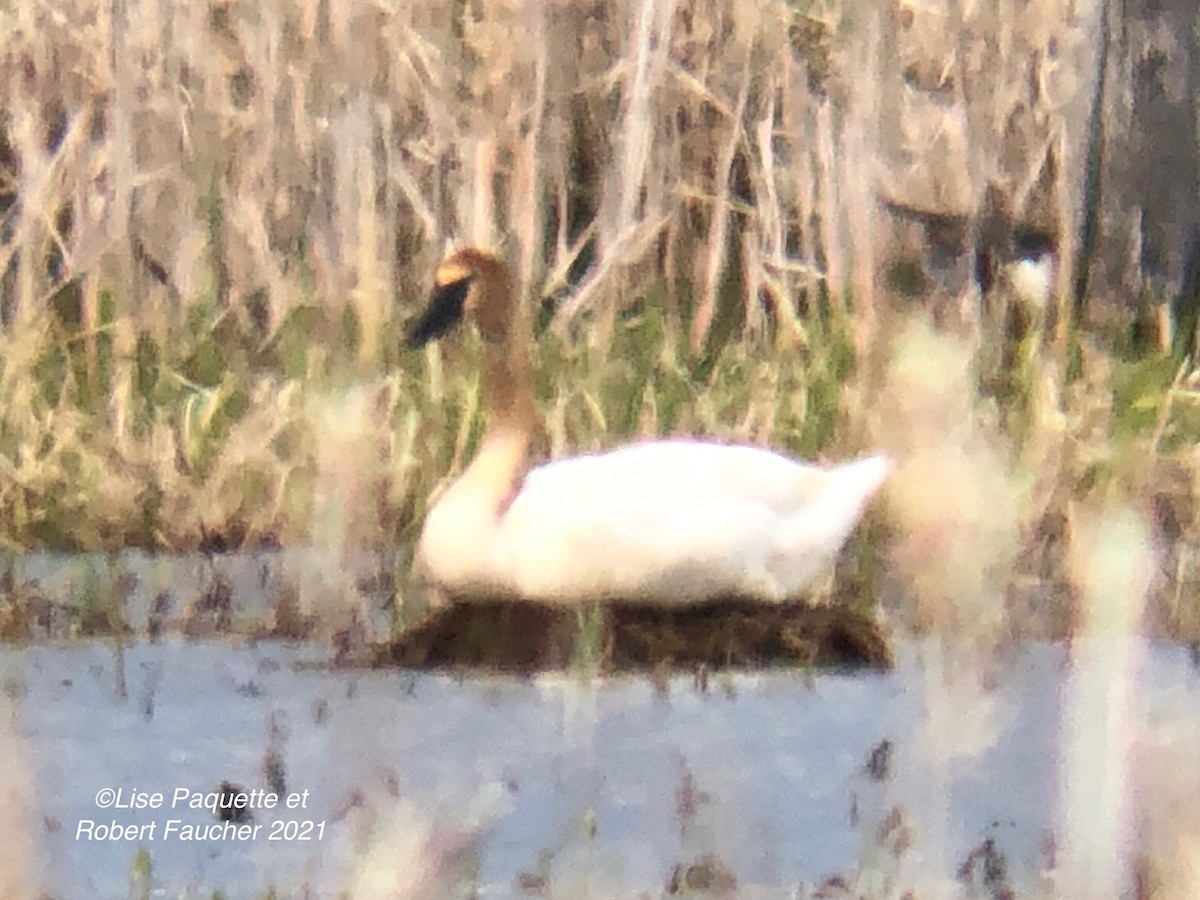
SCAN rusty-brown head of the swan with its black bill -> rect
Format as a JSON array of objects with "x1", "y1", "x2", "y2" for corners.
[{"x1": 408, "y1": 247, "x2": 515, "y2": 347}]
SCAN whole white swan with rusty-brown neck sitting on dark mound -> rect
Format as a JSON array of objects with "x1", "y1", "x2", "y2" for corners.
[{"x1": 409, "y1": 248, "x2": 890, "y2": 606}]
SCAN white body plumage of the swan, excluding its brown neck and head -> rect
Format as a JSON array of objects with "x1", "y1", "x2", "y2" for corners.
[{"x1": 420, "y1": 440, "x2": 890, "y2": 605}]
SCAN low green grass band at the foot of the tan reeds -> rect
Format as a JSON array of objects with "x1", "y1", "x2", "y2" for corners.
[{"x1": 0, "y1": 234, "x2": 1200, "y2": 643}]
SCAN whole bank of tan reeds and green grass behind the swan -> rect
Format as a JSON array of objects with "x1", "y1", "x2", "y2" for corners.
[{"x1": 0, "y1": 0, "x2": 1200, "y2": 637}]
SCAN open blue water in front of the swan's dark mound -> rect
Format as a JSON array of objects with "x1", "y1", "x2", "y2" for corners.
[{"x1": 0, "y1": 638, "x2": 1200, "y2": 898}]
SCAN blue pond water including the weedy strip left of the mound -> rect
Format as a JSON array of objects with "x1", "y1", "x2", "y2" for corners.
[{"x1": 0, "y1": 552, "x2": 1200, "y2": 900}]
